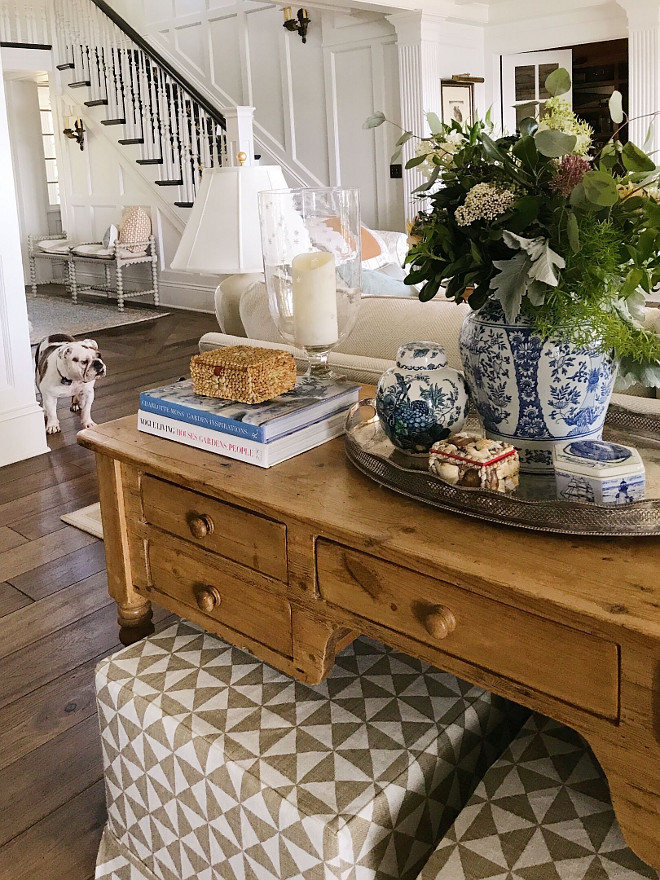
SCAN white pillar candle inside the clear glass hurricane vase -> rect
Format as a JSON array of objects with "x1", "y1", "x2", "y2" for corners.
[{"x1": 291, "y1": 252, "x2": 339, "y2": 348}]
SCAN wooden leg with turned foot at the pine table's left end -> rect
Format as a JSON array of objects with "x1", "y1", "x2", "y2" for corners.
[{"x1": 96, "y1": 455, "x2": 154, "y2": 645}]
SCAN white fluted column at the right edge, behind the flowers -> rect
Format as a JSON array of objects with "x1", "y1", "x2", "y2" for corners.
[{"x1": 617, "y1": 0, "x2": 660, "y2": 154}]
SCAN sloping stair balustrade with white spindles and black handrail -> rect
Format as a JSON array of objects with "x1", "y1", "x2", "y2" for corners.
[{"x1": 52, "y1": 0, "x2": 228, "y2": 208}]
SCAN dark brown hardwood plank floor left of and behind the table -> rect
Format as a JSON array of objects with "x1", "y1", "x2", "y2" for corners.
[{"x1": 0, "y1": 304, "x2": 211, "y2": 880}]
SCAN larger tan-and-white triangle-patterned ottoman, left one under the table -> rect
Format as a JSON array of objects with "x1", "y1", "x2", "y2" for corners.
[{"x1": 96, "y1": 622, "x2": 523, "y2": 880}]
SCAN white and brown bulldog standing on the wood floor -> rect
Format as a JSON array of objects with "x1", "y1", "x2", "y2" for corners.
[{"x1": 35, "y1": 333, "x2": 106, "y2": 434}]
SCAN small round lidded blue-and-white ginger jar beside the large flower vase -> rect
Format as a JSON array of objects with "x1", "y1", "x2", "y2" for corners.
[{"x1": 376, "y1": 342, "x2": 469, "y2": 453}]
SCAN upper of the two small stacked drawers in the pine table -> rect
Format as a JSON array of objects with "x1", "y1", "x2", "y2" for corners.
[{"x1": 141, "y1": 476, "x2": 287, "y2": 581}]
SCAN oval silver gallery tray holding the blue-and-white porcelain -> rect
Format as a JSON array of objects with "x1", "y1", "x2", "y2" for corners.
[{"x1": 345, "y1": 398, "x2": 660, "y2": 536}]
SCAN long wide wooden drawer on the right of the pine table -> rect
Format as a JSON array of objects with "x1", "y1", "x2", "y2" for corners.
[{"x1": 316, "y1": 539, "x2": 619, "y2": 718}]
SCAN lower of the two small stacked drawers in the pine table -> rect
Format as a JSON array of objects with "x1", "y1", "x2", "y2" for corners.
[{"x1": 147, "y1": 541, "x2": 292, "y2": 657}]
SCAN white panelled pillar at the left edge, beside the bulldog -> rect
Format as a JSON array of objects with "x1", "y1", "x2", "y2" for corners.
[{"x1": 0, "y1": 49, "x2": 48, "y2": 467}]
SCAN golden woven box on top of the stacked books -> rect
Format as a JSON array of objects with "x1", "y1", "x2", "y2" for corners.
[{"x1": 190, "y1": 345, "x2": 296, "y2": 403}]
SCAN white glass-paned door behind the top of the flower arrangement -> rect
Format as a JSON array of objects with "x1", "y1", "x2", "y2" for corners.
[{"x1": 501, "y1": 49, "x2": 573, "y2": 134}]
